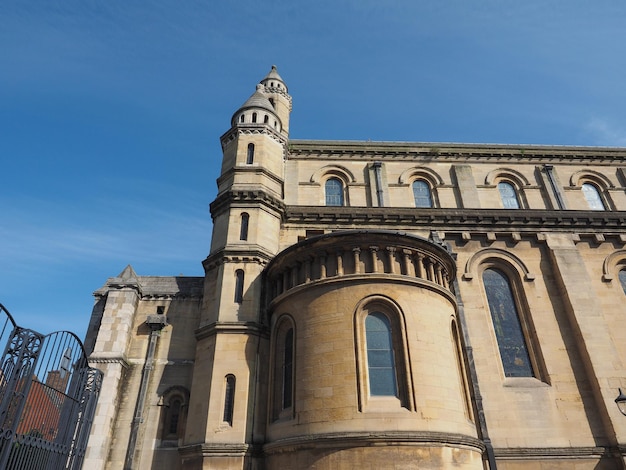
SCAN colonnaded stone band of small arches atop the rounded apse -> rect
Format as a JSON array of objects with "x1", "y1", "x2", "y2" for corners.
[{"x1": 265, "y1": 230, "x2": 456, "y2": 304}]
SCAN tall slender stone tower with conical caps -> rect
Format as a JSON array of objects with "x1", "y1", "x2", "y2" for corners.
[{"x1": 182, "y1": 66, "x2": 291, "y2": 468}]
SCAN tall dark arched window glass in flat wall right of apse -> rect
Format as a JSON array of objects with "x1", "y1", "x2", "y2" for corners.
[{"x1": 483, "y1": 268, "x2": 535, "y2": 377}]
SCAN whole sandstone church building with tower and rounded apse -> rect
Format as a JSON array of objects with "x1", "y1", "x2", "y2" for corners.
[{"x1": 85, "y1": 67, "x2": 626, "y2": 470}]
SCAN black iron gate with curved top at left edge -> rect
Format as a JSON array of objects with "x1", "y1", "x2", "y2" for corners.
[{"x1": 0, "y1": 304, "x2": 102, "y2": 470}]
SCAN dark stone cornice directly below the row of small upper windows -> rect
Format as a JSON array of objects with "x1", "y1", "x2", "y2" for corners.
[{"x1": 284, "y1": 206, "x2": 626, "y2": 233}]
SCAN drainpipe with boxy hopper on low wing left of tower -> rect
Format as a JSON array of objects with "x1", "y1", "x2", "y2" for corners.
[{"x1": 124, "y1": 310, "x2": 167, "y2": 470}]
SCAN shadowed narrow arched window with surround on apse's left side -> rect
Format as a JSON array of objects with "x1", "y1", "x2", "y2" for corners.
[{"x1": 271, "y1": 314, "x2": 296, "y2": 420}]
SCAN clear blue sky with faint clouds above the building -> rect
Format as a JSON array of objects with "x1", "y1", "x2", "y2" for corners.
[{"x1": 0, "y1": 0, "x2": 626, "y2": 337}]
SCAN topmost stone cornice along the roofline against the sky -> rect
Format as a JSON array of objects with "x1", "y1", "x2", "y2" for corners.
[{"x1": 288, "y1": 140, "x2": 626, "y2": 164}]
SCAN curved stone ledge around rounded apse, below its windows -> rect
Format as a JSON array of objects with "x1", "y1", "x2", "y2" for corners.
[{"x1": 263, "y1": 431, "x2": 485, "y2": 454}]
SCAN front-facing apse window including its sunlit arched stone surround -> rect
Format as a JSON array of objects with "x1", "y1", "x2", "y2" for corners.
[{"x1": 354, "y1": 296, "x2": 415, "y2": 411}]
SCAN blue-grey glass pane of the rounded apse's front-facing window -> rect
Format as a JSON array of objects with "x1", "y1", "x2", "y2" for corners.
[{"x1": 365, "y1": 312, "x2": 398, "y2": 397}]
